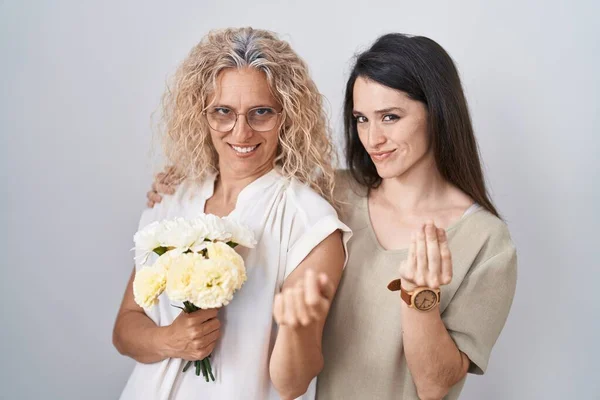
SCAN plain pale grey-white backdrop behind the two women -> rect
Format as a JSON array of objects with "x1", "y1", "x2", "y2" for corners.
[{"x1": 0, "y1": 0, "x2": 600, "y2": 400}]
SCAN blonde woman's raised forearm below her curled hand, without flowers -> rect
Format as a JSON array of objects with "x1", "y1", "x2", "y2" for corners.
[{"x1": 269, "y1": 325, "x2": 323, "y2": 399}]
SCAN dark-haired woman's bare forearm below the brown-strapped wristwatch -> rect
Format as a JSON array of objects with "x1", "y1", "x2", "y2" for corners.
[{"x1": 402, "y1": 302, "x2": 469, "y2": 400}]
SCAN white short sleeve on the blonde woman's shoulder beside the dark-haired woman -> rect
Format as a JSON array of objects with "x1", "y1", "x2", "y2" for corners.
[{"x1": 284, "y1": 181, "x2": 352, "y2": 279}]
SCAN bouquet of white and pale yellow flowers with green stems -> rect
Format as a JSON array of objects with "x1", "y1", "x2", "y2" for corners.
[{"x1": 133, "y1": 214, "x2": 256, "y2": 382}]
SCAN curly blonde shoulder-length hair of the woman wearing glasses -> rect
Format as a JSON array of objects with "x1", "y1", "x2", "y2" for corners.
[{"x1": 162, "y1": 28, "x2": 338, "y2": 209}]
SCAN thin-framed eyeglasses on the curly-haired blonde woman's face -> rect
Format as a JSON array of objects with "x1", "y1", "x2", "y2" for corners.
[{"x1": 204, "y1": 107, "x2": 282, "y2": 133}]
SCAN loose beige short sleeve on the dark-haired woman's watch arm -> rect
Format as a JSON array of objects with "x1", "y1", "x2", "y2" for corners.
[{"x1": 442, "y1": 247, "x2": 517, "y2": 375}]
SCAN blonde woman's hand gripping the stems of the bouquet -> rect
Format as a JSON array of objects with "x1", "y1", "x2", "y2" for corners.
[{"x1": 162, "y1": 309, "x2": 221, "y2": 361}]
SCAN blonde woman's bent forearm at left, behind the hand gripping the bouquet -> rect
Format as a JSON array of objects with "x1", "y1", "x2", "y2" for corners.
[{"x1": 113, "y1": 311, "x2": 169, "y2": 364}]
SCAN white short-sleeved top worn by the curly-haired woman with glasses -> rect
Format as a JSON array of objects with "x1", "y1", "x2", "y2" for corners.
[{"x1": 121, "y1": 169, "x2": 351, "y2": 400}]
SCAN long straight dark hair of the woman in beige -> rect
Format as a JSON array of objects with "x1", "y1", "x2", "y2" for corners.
[{"x1": 344, "y1": 33, "x2": 499, "y2": 216}]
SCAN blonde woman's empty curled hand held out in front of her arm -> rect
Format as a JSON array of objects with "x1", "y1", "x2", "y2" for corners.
[{"x1": 273, "y1": 269, "x2": 335, "y2": 328}]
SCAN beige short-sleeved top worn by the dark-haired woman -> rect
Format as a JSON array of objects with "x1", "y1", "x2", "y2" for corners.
[{"x1": 317, "y1": 174, "x2": 517, "y2": 400}]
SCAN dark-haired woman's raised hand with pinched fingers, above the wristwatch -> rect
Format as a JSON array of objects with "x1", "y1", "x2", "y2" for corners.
[{"x1": 400, "y1": 221, "x2": 452, "y2": 292}]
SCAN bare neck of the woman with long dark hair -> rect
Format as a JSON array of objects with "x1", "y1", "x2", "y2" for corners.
[{"x1": 374, "y1": 154, "x2": 450, "y2": 213}]
